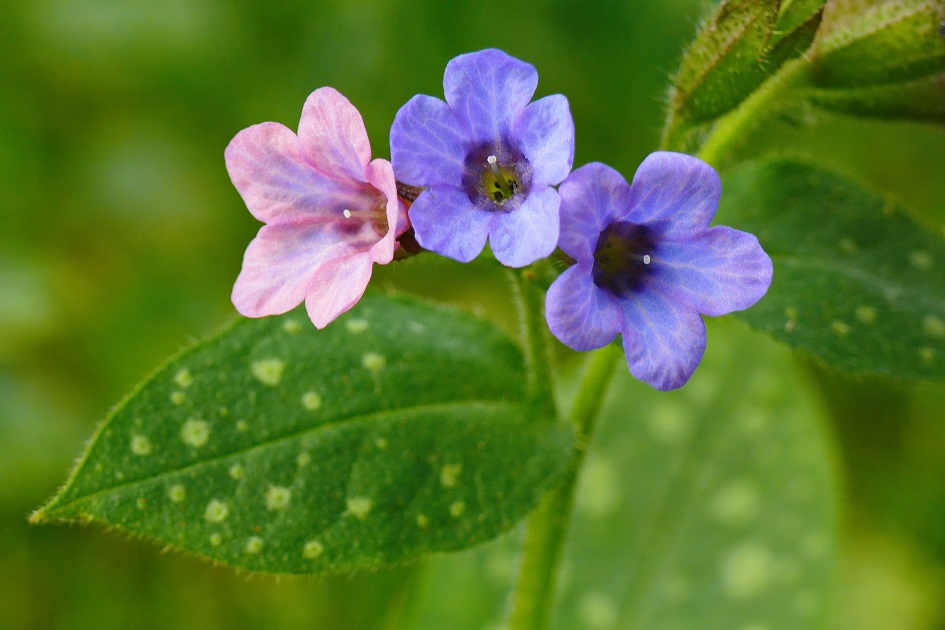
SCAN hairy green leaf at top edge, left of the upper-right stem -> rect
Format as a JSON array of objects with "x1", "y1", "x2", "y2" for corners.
[{"x1": 672, "y1": 0, "x2": 778, "y2": 124}]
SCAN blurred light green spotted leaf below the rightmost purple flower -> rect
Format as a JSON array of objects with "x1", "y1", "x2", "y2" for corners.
[{"x1": 556, "y1": 320, "x2": 838, "y2": 630}]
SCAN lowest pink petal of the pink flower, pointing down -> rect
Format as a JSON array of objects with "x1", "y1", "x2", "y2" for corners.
[{"x1": 305, "y1": 252, "x2": 373, "y2": 328}]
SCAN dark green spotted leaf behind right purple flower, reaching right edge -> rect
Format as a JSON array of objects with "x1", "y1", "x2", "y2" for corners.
[{"x1": 718, "y1": 161, "x2": 945, "y2": 379}]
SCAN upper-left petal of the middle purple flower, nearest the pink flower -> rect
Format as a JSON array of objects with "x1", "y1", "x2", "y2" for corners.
[{"x1": 390, "y1": 94, "x2": 467, "y2": 186}]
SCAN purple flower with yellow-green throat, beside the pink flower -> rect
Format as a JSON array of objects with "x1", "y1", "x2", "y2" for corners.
[{"x1": 390, "y1": 50, "x2": 574, "y2": 267}]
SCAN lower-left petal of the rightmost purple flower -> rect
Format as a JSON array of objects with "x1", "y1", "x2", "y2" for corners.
[{"x1": 545, "y1": 263, "x2": 621, "y2": 352}]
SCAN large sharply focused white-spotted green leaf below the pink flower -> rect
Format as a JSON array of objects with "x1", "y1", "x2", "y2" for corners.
[{"x1": 33, "y1": 296, "x2": 573, "y2": 573}]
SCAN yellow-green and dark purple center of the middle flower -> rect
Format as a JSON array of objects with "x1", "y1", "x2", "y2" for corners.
[{"x1": 463, "y1": 143, "x2": 531, "y2": 212}]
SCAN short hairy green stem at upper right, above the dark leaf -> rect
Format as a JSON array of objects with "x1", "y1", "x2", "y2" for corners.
[{"x1": 698, "y1": 57, "x2": 810, "y2": 168}]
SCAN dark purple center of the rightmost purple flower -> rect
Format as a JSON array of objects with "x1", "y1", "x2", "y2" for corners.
[{"x1": 594, "y1": 221, "x2": 655, "y2": 295}]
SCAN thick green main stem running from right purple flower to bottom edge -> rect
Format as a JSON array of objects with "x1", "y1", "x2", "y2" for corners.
[{"x1": 509, "y1": 344, "x2": 622, "y2": 630}]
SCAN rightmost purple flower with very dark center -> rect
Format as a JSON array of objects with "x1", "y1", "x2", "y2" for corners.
[{"x1": 545, "y1": 152, "x2": 772, "y2": 391}]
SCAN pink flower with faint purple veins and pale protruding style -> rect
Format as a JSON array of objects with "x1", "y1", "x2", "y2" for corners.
[{"x1": 225, "y1": 87, "x2": 408, "y2": 328}]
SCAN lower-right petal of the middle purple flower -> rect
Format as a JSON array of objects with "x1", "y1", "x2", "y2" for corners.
[{"x1": 489, "y1": 186, "x2": 561, "y2": 267}]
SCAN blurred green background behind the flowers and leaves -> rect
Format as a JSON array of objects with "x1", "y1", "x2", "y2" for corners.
[{"x1": 0, "y1": 0, "x2": 945, "y2": 629}]
